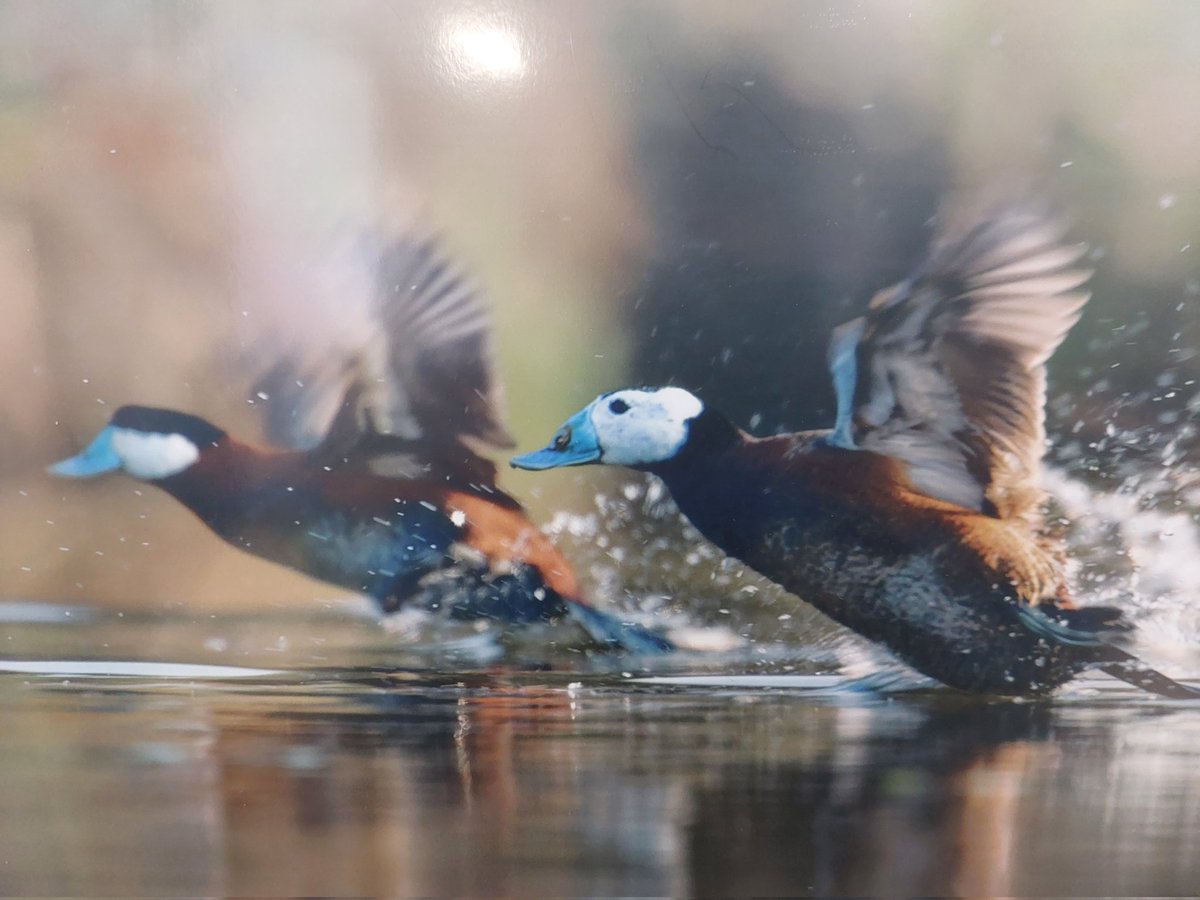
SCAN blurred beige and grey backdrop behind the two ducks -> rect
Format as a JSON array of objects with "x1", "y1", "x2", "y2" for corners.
[{"x1": 0, "y1": 0, "x2": 1200, "y2": 622}]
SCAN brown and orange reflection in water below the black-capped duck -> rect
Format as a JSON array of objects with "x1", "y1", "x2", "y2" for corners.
[{"x1": 218, "y1": 684, "x2": 682, "y2": 895}]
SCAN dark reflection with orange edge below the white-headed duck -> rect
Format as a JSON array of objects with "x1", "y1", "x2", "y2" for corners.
[{"x1": 689, "y1": 703, "x2": 1055, "y2": 895}]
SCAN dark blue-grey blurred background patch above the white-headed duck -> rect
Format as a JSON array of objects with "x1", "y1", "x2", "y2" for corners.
[{"x1": 628, "y1": 47, "x2": 948, "y2": 432}]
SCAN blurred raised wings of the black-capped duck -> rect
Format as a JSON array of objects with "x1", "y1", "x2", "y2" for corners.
[{"x1": 256, "y1": 232, "x2": 514, "y2": 485}]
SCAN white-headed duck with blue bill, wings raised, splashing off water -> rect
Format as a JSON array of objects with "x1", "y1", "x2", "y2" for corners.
[{"x1": 512, "y1": 209, "x2": 1200, "y2": 698}]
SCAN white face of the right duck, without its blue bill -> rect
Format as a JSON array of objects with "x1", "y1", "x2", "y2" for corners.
[{"x1": 590, "y1": 388, "x2": 704, "y2": 466}]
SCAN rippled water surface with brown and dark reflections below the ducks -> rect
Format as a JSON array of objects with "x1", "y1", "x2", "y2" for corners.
[{"x1": 0, "y1": 607, "x2": 1200, "y2": 896}]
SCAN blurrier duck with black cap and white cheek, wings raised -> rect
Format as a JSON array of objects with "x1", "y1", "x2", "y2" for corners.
[{"x1": 49, "y1": 234, "x2": 671, "y2": 653}]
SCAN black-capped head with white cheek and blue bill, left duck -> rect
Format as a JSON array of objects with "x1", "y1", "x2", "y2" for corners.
[{"x1": 49, "y1": 407, "x2": 226, "y2": 481}]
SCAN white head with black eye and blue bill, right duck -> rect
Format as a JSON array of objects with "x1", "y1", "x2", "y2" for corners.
[{"x1": 512, "y1": 388, "x2": 704, "y2": 469}]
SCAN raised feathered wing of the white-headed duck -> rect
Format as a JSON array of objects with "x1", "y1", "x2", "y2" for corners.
[{"x1": 829, "y1": 209, "x2": 1091, "y2": 517}]
